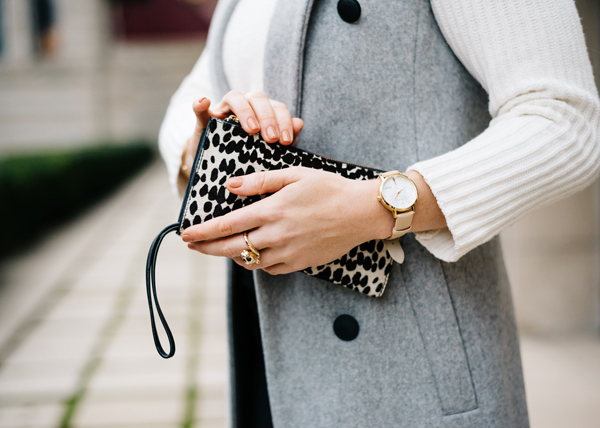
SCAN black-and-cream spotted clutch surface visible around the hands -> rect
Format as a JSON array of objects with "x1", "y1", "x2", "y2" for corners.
[{"x1": 179, "y1": 118, "x2": 393, "y2": 297}]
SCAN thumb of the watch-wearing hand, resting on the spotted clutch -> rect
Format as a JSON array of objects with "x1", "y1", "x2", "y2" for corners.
[{"x1": 226, "y1": 168, "x2": 301, "y2": 198}]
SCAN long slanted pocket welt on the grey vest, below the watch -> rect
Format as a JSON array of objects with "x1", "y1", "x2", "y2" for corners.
[{"x1": 402, "y1": 239, "x2": 478, "y2": 416}]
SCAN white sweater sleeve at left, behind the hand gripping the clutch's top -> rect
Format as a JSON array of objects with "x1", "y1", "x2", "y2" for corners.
[{"x1": 158, "y1": 49, "x2": 215, "y2": 194}]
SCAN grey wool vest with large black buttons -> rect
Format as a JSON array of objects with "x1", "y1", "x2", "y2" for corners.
[{"x1": 209, "y1": 0, "x2": 528, "y2": 428}]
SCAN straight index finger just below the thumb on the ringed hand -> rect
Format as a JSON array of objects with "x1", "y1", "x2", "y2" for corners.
[{"x1": 181, "y1": 201, "x2": 266, "y2": 242}]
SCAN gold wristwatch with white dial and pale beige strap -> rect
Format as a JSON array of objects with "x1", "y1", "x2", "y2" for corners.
[{"x1": 377, "y1": 171, "x2": 418, "y2": 239}]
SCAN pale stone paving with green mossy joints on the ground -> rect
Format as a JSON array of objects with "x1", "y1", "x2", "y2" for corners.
[{"x1": 0, "y1": 164, "x2": 600, "y2": 428}]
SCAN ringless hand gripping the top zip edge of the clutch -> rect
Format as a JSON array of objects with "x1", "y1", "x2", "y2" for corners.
[{"x1": 184, "y1": 91, "x2": 304, "y2": 171}]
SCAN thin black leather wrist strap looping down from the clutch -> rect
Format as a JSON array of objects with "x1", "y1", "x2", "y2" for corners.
[{"x1": 146, "y1": 223, "x2": 179, "y2": 358}]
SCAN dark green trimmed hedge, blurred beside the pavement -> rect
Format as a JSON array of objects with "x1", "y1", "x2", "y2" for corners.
[{"x1": 0, "y1": 141, "x2": 155, "y2": 257}]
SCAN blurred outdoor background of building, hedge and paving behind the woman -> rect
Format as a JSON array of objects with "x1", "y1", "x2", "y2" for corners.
[{"x1": 0, "y1": 0, "x2": 600, "y2": 428}]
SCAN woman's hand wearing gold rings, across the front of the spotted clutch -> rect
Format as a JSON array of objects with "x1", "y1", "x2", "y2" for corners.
[{"x1": 182, "y1": 167, "x2": 394, "y2": 275}]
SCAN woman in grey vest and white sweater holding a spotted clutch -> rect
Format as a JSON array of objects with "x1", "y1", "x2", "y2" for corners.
[{"x1": 160, "y1": 0, "x2": 600, "y2": 428}]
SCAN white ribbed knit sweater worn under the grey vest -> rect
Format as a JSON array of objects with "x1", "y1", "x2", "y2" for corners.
[{"x1": 159, "y1": 0, "x2": 600, "y2": 261}]
